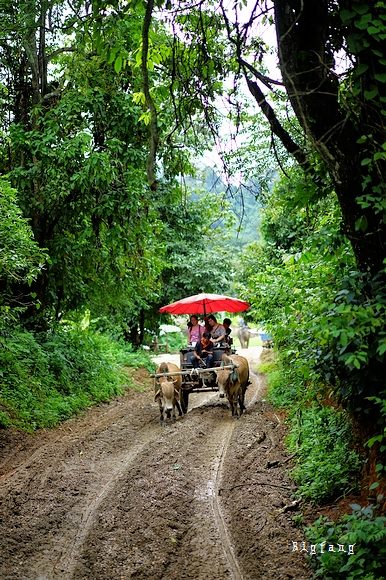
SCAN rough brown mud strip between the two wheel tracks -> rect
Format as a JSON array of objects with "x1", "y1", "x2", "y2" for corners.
[{"x1": 65, "y1": 408, "x2": 238, "y2": 580}]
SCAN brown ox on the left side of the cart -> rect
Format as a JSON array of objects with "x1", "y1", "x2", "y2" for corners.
[{"x1": 154, "y1": 363, "x2": 182, "y2": 424}]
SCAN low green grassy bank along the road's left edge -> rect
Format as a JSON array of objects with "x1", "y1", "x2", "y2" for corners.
[{"x1": 0, "y1": 327, "x2": 154, "y2": 431}]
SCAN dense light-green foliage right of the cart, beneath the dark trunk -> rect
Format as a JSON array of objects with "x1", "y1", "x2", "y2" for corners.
[{"x1": 242, "y1": 165, "x2": 385, "y2": 420}]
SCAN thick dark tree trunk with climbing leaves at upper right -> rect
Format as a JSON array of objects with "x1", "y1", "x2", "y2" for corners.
[{"x1": 274, "y1": 0, "x2": 386, "y2": 275}]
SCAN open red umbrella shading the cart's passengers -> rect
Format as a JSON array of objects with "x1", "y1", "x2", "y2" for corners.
[{"x1": 159, "y1": 294, "x2": 249, "y2": 316}]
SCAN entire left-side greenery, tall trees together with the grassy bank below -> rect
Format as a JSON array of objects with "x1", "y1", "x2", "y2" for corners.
[{"x1": 0, "y1": 0, "x2": 235, "y2": 428}]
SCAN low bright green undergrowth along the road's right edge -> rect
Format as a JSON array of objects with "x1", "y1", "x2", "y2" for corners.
[{"x1": 259, "y1": 359, "x2": 362, "y2": 505}]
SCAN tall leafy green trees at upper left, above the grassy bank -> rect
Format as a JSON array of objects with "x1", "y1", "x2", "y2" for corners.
[{"x1": 0, "y1": 0, "x2": 240, "y2": 342}]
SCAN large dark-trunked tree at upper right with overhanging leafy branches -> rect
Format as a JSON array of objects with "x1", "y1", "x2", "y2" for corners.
[{"x1": 140, "y1": 0, "x2": 386, "y2": 277}]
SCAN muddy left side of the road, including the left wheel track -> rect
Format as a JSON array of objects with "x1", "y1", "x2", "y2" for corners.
[{"x1": 0, "y1": 393, "x2": 163, "y2": 580}]
